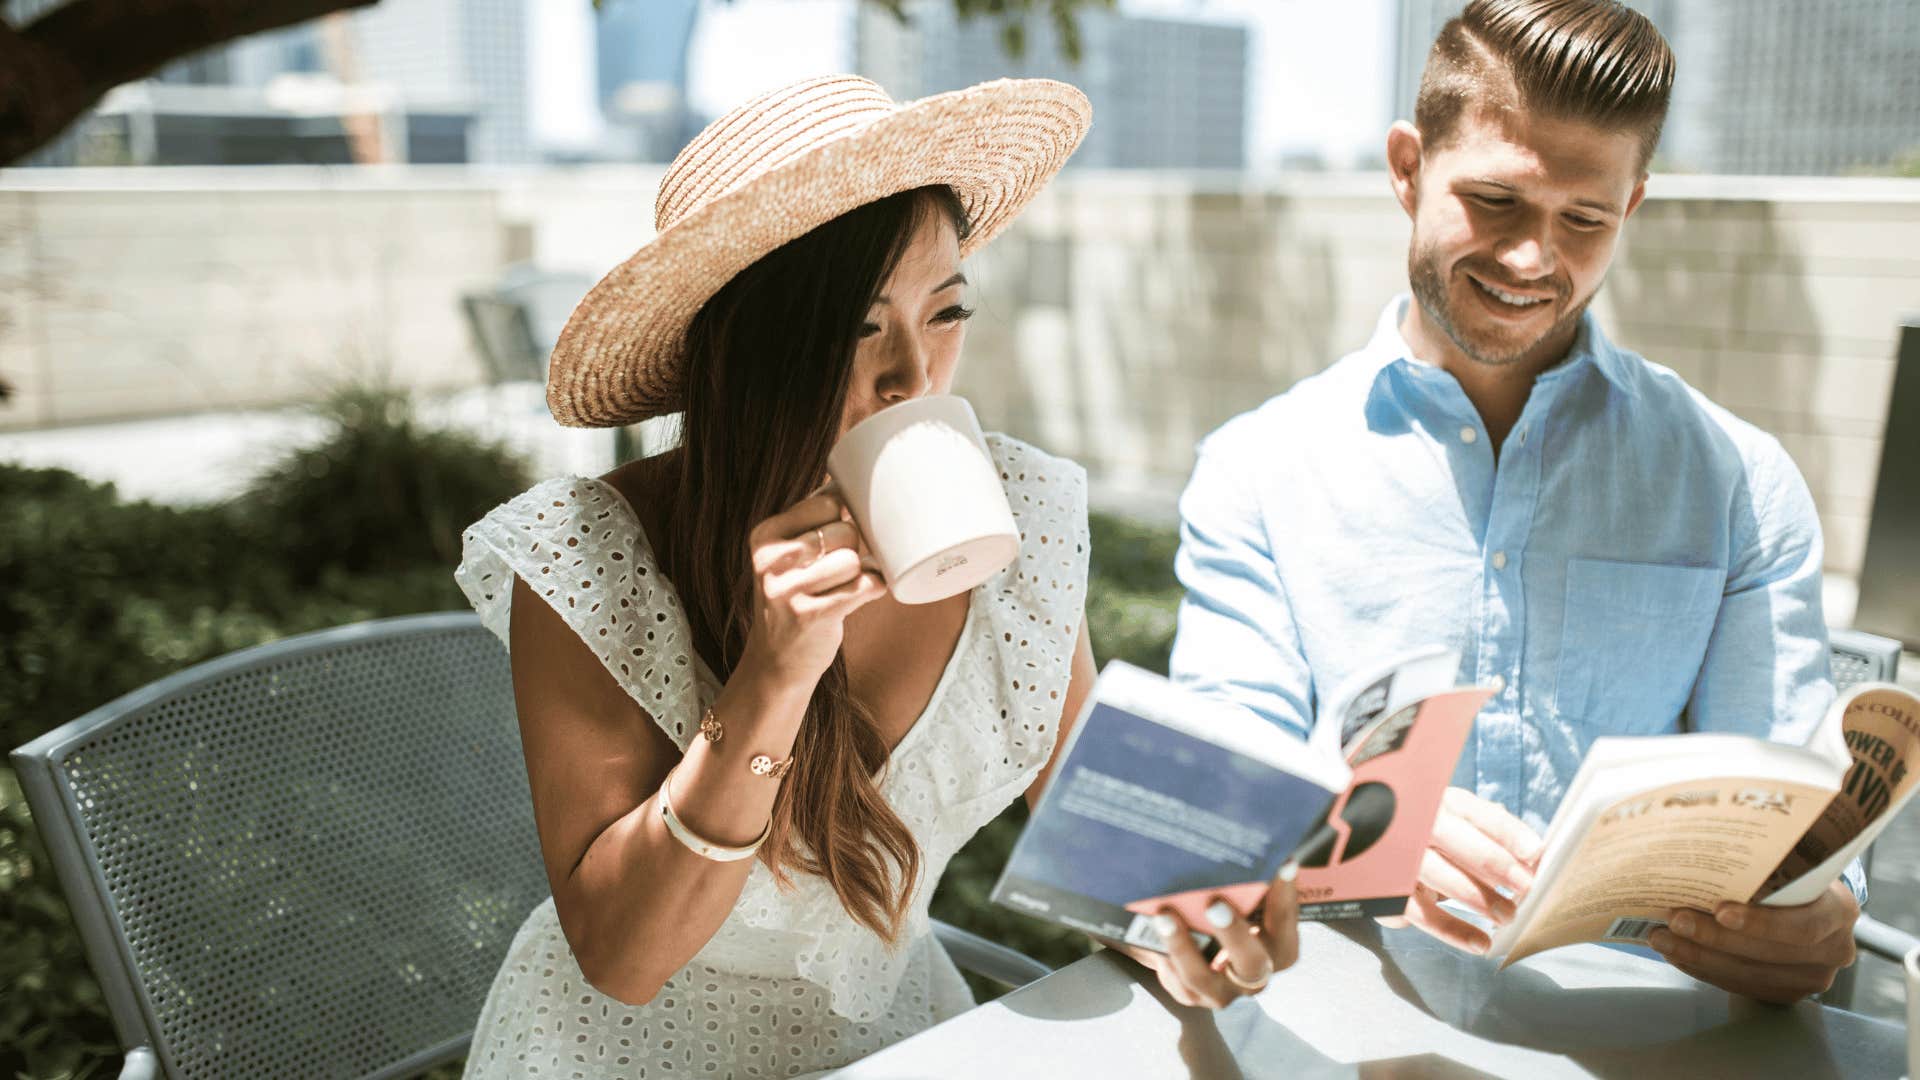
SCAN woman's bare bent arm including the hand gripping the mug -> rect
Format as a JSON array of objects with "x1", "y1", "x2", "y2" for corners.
[{"x1": 509, "y1": 478, "x2": 887, "y2": 1003}]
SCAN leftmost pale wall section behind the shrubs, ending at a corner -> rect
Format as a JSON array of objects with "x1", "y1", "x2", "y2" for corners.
[{"x1": 0, "y1": 169, "x2": 505, "y2": 429}]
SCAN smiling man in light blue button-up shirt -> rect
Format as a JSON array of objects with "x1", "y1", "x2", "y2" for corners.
[{"x1": 1173, "y1": 0, "x2": 1864, "y2": 1001}]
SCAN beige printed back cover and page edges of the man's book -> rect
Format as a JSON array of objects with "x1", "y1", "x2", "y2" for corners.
[{"x1": 1494, "y1": 734, "x2": 1837, "y2": 963}]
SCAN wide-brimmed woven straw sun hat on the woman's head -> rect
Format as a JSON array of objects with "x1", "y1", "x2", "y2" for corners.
[{"x1": 547, "y1": 75, "x2": 1092, "y2": 427}]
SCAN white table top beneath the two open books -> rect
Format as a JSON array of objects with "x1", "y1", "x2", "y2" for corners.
[{"x1": 837, "y1": 922, "x2": 1907, "y2": 1080}]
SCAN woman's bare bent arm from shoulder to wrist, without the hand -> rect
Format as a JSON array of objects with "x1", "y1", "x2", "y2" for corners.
[{"x1": 511, "y1": 580, "x2": 806, "y2": 1005}]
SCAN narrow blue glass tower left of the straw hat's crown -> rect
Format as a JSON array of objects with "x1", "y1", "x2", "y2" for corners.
[{"x1": 593, "y1": 0, "x2": 701, "y2": 161}]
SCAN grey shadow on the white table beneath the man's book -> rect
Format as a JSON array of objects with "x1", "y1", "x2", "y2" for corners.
[{"x1": 1332, "y1": 922, "x2": 1841, "y2": 1080}]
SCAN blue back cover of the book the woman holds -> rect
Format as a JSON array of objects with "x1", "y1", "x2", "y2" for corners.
[{"x1": 993, "y1": 663, "x2": 1350, "y2": 949}]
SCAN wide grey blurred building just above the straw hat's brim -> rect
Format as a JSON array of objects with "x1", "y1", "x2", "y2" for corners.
[{"x1": 854, "y1": 0, "x2": 1248, "y2": 169}]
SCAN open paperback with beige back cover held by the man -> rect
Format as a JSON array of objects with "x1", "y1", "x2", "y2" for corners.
[{"x1": 1492, "y1": 682, "x2": 1920, "y2": 963}]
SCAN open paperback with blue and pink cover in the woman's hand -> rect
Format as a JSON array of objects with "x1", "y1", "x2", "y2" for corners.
[{"x1": 993, "y1": 651, "x2": 1490, "y2": 949}]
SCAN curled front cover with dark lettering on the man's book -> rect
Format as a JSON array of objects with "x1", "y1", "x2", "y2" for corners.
[{"x1": 1763, "y1": 682, "x2": 1920, "y2": 905}]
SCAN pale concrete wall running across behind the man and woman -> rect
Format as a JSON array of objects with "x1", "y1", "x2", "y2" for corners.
[{"x1": 0, "y1": 169, "x2": 1920, "y2": 575}]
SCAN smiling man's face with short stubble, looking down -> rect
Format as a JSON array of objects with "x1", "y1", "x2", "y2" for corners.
[{"x1": 1388, "y1": 108, "x2": 1645, "y2": 365}]
